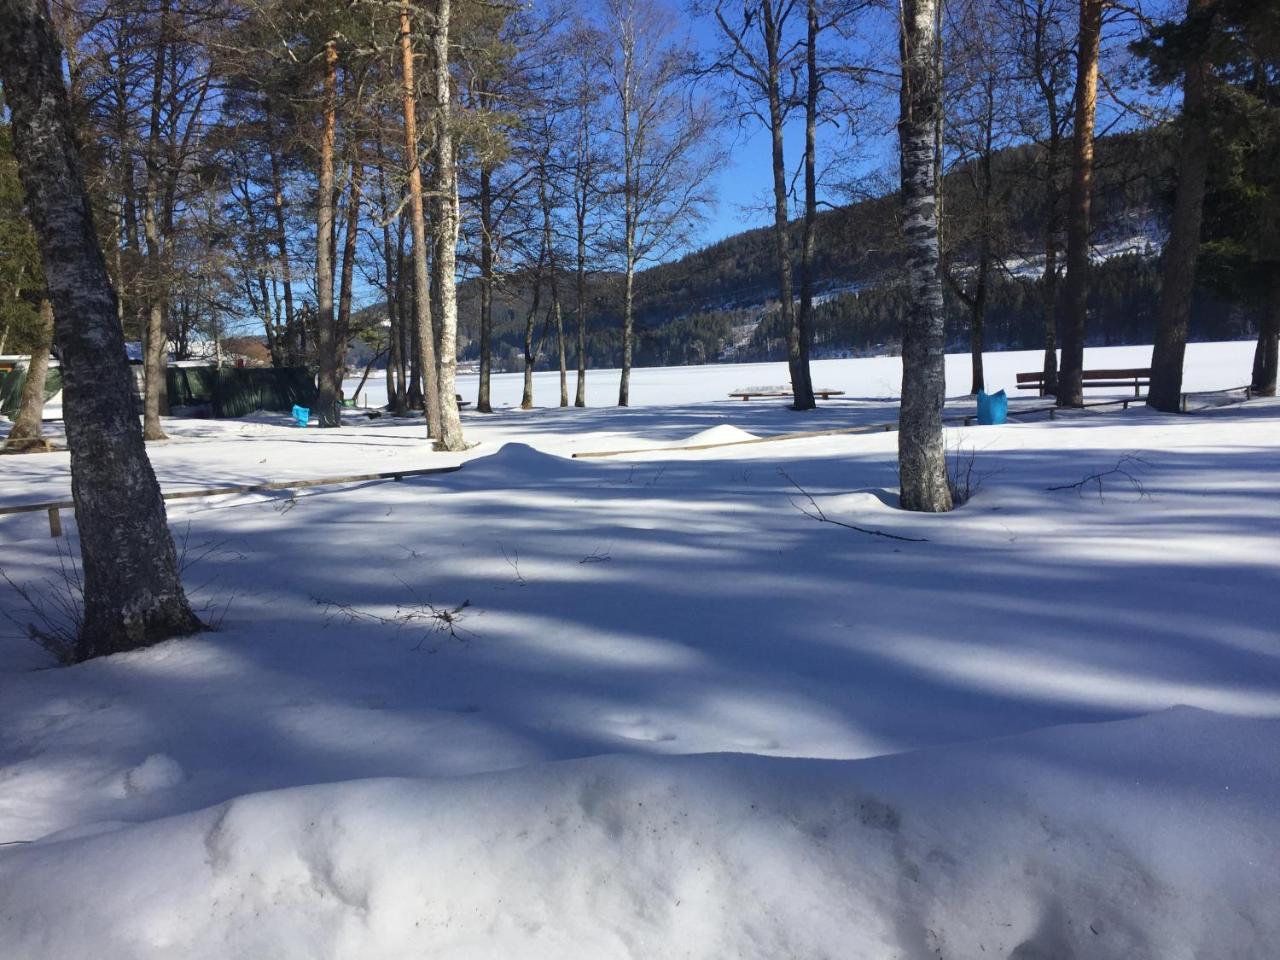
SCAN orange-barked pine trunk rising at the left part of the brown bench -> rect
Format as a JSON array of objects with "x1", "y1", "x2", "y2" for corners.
[{"x1": 1057, "y1": 0, "x2": 1103, "y2": 407}]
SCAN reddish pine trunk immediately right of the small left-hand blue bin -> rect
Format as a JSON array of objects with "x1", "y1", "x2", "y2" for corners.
[{"x1": 315, "y1": 40, "x2": 342, "y2": 428}]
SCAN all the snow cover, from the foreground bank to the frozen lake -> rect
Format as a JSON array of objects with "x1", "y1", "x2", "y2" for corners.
[{"x1": 0, "y1": 343, "x2": 1280, "y2": 960}]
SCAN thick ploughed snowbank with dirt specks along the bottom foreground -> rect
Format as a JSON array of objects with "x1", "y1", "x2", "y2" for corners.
[{"x1": 0, "y1": 708, "x2": 1280, "y2": 960}]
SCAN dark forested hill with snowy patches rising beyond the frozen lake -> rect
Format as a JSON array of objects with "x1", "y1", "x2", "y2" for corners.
[{"x1": 460, "y1": 129, "x2": 1172, "y2": 367}]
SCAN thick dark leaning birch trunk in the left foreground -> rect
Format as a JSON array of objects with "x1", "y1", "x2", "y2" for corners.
[{"x1": 0, "y1": 0, "x2": 201, "y2": 659}]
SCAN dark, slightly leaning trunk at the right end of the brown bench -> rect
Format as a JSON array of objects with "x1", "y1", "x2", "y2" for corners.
[{"x1": 1147, "y1": 0, "x2": 1212, "y2": 413}]
